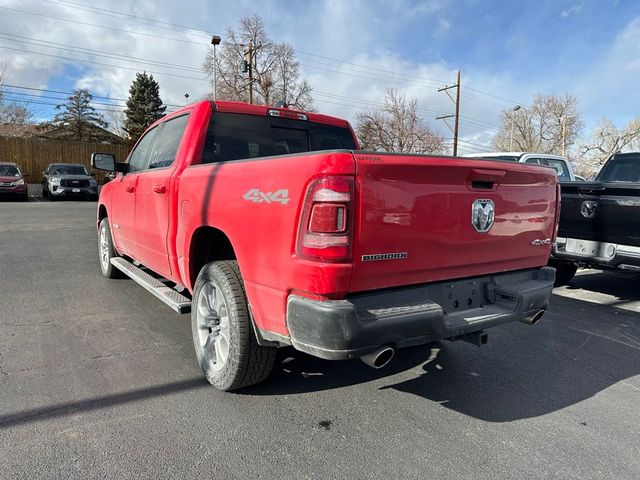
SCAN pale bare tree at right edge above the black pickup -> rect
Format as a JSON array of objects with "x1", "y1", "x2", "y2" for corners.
[{"x1": 576, "y1": 117, "x2": 640, "y2": 177}]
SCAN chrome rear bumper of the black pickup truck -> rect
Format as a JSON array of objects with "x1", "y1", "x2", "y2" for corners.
[{"x1": 552, "y1": 237, "x2": 640, "y2": 272}]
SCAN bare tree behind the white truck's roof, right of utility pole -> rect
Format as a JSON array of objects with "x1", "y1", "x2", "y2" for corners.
[{"x1": 493, "y1": 94, "x2": 582, "y2": 154}]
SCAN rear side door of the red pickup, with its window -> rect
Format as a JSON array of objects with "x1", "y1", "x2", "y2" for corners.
[{"x1": 135, "y1": 114, "x2": 189, "y2": 276}]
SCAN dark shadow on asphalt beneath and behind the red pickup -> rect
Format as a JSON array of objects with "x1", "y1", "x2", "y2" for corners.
[{"x1": 243, "y1": 296, "x2": 640, "y2": 422}]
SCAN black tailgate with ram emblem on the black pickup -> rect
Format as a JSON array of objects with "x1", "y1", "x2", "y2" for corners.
[{"x1": 558, "y1": 182, "x2": 640, "y2": 246}]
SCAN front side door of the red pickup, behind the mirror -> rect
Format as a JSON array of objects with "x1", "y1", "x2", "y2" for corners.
[{"x1": 109, "y1": 127, "x2": 158, "y2": 259}]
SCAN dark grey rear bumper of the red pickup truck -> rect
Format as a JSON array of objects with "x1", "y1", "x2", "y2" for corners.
[{"x1": 287, "y1": 267, "x2": 555, "y2": 360}]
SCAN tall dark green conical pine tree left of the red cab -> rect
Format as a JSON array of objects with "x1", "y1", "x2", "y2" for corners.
[{"x1": 124, "y1": 72, "x2": 167, "y2": 142}]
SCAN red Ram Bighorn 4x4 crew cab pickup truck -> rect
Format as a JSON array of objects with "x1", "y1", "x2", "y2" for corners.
[{"x1": 92, "y1": 102, "x2": 558, "y2": 390}]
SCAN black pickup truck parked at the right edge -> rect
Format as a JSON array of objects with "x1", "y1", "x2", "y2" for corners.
[{"x1": 550, "y1": 152, "x2": 640, "y2": 284}]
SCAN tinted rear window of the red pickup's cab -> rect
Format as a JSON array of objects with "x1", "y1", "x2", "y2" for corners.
[{"x1": 202, "y1": 113, "x2": 356, "y2": 163}]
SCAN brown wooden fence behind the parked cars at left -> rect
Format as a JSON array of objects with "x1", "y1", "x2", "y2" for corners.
[{"x1": 0, "y1": 137, "x2": 130, "y2": 183}]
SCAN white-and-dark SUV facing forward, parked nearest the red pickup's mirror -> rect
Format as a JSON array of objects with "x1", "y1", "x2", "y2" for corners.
[{"x1": 42, "y1": 163, "x2": 98, "y2": 200}]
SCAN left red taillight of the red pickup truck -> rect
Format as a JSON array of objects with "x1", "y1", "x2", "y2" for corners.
[{"x1": 296, "y1": 177, "x2": 354, "y2": 262}]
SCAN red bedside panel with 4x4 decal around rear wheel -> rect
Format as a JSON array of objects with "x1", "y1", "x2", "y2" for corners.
[{"x1": 176, "y1": 152, "x2": 355, "y2": 335}]
